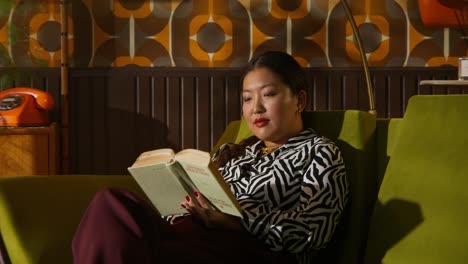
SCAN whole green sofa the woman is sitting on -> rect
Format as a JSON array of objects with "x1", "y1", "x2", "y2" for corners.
[{"x1": 0, "y1": 95, "x2": 468, "y2": 264}]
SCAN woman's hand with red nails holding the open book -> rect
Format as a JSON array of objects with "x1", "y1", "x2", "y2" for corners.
[{"x1": 181, "y1": 192, "x2": 242, "y2": 230}]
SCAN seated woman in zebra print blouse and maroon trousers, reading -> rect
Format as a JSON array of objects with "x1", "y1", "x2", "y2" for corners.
[{"x1": 73, "y1": 52, "x2": 348, "y2": 263}]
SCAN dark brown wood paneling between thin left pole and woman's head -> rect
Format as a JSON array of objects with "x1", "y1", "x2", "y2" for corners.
[{"x1": 70, "y1": 68, "x2": 247, "y2": 174}]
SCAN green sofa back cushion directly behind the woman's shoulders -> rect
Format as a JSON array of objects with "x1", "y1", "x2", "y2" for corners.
[{"x1": 215, "y1": 110, "x2": 377, "y2": 264}]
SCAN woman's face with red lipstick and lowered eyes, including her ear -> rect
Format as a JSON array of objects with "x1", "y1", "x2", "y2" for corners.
[{"x1": 242, "y1": 68, "x2": 305, "y2": 146}]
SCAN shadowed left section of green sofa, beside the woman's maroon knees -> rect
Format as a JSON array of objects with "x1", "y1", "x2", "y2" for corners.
[{"x1": 0, "y1": 175, "x2": 141, "y2": 264}]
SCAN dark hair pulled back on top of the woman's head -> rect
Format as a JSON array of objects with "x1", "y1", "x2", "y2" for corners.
[{"x1": 244, "y1": 51, "x2": 307, "y2": 95}]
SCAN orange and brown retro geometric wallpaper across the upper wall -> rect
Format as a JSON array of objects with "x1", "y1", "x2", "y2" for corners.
[{"x1": 0, "y1": 0, "x2": 467, "y2": 67}]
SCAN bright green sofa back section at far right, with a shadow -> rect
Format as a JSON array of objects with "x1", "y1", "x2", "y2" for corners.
[{"x1": 365, "y1": 95, "x2": 468, "y2": 264}]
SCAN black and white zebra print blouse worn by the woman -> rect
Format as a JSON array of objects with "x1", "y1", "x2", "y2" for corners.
[{"x1": 215, "y1": 129, "x2": 348, "y2": 253}]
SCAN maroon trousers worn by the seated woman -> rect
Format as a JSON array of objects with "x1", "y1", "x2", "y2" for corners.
[{"x1": 72, "y1": 189, "x2": 296, "y2": 264}]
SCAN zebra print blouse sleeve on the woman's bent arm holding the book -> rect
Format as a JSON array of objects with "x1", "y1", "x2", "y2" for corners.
[{"x1": 241, "y1": 143, "x2": 348, "y2": 253}]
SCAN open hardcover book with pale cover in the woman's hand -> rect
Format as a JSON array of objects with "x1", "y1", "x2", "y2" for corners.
[{"x1": 128, "y1": 149, "x2": 242, "y2": 217}]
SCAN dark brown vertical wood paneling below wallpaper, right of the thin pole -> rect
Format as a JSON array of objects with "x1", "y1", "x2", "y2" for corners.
[{"x1": 69, "y1": 68, "x2": 465, "y2": 174}]
